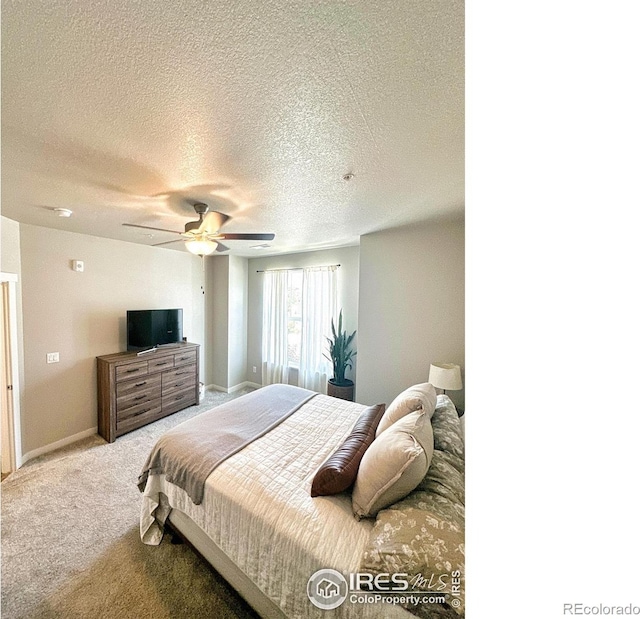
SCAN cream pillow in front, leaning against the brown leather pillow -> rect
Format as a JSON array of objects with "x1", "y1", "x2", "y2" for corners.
[{"x1": 352, "y1": 411, "x2": 433, "y2": 518}]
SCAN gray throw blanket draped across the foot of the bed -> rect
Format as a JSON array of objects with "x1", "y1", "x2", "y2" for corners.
[{"x1": 138, "y1": 385, "x2": 316, "y2": 505}]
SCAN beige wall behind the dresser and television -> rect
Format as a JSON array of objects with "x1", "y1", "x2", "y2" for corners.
[{"x1": 20, "y1": 224, "x2": 204, "y2": 453}]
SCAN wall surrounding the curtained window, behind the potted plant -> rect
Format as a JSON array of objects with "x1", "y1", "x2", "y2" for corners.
[{"x1": 247, "y1": 247, "x2": 359, "y2": 384}]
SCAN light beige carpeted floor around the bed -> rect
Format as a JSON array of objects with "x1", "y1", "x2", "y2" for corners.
[{"x1": 1, "y1": 390, "x2": 257, "y2": 619}]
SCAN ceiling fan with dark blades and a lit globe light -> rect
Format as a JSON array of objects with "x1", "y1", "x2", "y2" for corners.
[{"x1": 122, "y1": 202, "x2": 275, "y2": 256}]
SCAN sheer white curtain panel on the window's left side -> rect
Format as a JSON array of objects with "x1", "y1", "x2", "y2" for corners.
[{"x1": 262, "y1": 271, "x2": 289, "y2": 385}]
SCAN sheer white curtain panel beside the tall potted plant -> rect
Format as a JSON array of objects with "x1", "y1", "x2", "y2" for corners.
[{"x1": 298, "y1": 266, "x2": 338, "y2": 393}]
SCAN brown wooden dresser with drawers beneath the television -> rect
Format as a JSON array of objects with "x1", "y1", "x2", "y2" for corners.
[{"x1": 97, "y1": 342, "x2": 200, "y2": 443}]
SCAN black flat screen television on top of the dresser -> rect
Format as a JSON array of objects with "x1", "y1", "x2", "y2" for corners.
[{"x1": 127, "y1": 309, "x2": 182, "y2": 350}]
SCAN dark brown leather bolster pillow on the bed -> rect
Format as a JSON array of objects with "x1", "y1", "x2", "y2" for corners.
[{"x1": 311, "y1": 404, "x2": 385, "y2": 496}]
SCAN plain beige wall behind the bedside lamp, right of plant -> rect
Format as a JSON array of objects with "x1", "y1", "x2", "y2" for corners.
[{"x1": 356, "y1": 220, "x2": 465, "y2": 409}]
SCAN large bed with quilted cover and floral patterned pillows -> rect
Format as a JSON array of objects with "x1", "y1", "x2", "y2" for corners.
[{"x1": 139, "y1": 385, "x2": 464, "y2": 619}]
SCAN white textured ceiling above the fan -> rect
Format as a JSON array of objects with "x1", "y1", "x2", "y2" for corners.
[{"x1": 2, "y1": 0, "x2": 464, "y2": 256}]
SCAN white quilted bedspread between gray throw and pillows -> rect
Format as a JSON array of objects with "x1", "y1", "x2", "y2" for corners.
[{"x1": 140, "y1": 395, "x2": 412, "y2": 619}]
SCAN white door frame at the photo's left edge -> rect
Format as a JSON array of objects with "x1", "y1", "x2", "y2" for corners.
[{"x1": 0, "y1": 273, "x2": 23, "y2": 473}]
